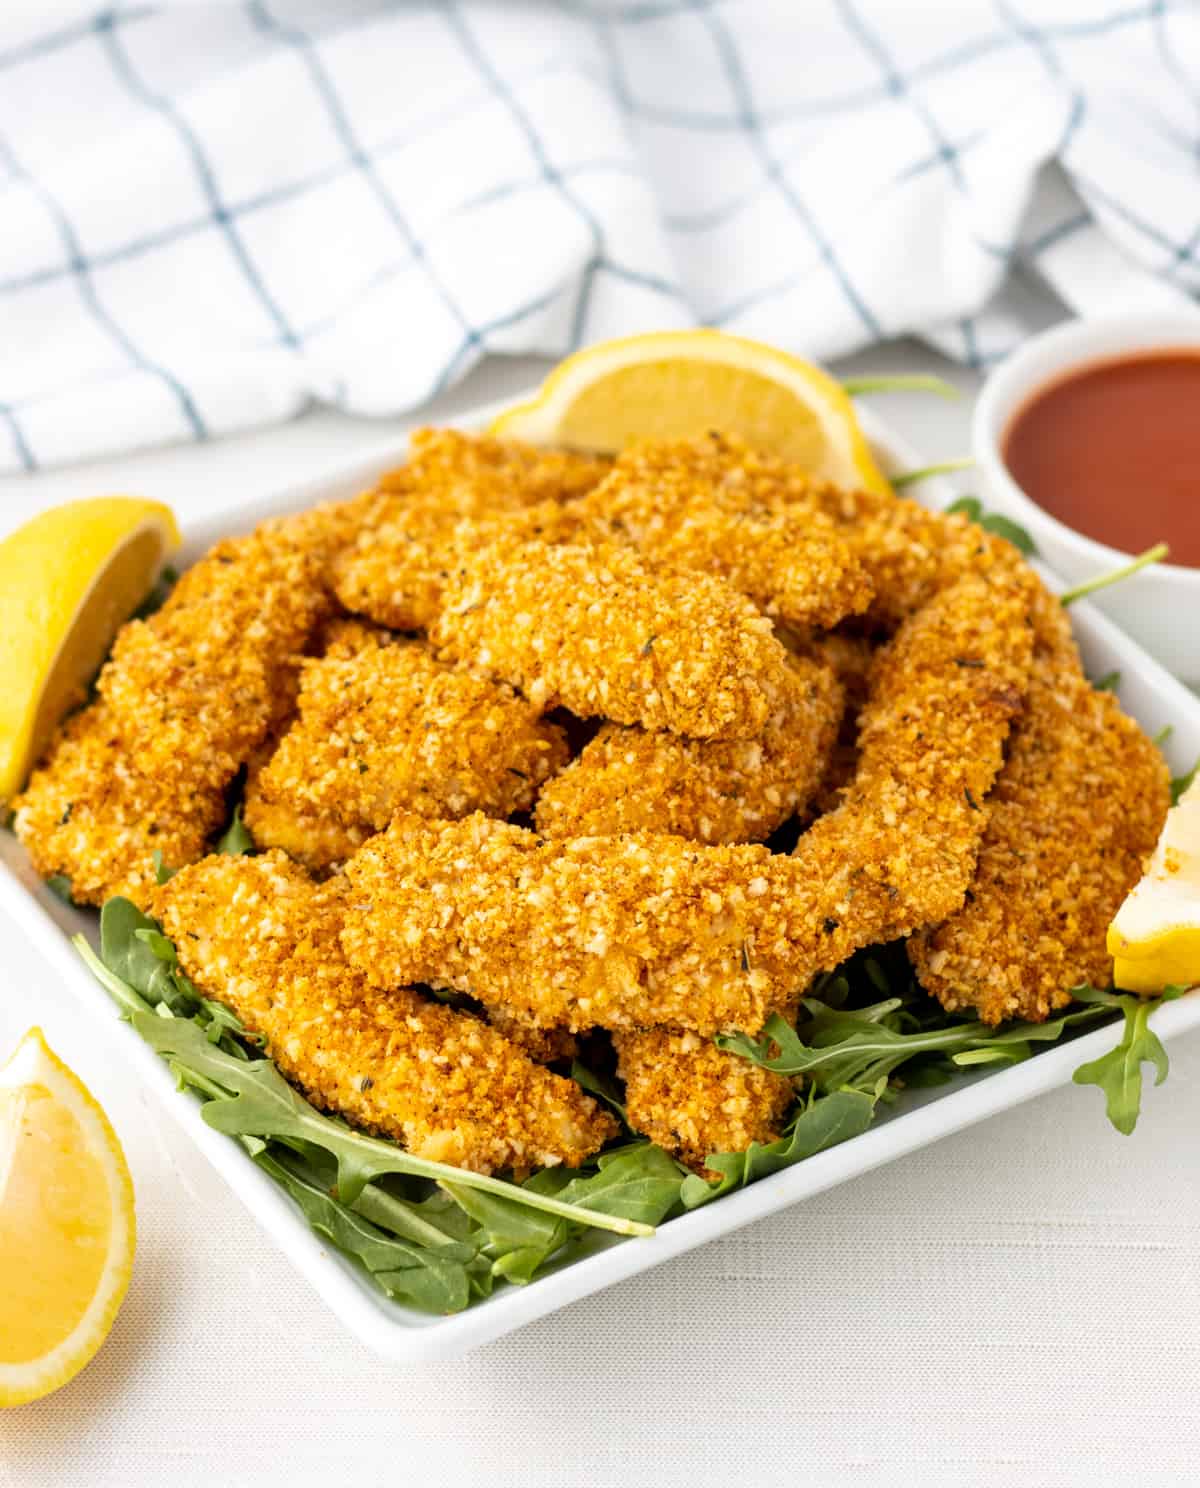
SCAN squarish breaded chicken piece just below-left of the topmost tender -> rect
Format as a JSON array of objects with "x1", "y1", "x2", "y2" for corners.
[{"x1": 247, "y1": 622, "x2": 567, "y2": 866}]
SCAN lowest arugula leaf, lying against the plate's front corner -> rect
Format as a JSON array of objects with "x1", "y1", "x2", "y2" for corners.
[{"x1": 253, "y1": 1149, "x2": 473, "y2": 1312}]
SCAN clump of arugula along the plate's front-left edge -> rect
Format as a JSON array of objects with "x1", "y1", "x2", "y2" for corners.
[{"x1": 74, "y1": 899, "x2": 666, "y2": 1311}]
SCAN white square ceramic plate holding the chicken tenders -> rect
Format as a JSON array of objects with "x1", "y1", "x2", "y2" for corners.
[{"x1": 0, "y1": 398, "x2": 1200, "y2": 1360}]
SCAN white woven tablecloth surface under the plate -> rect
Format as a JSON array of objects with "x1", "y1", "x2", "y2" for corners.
[{"x1": 0, "y1": 337, "x2": 1200, "y2": 1488}]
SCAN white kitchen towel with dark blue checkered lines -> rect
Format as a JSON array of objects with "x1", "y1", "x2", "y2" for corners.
[{"x1": 0, "y1": 0, "x2": 1200, "y2": 470}]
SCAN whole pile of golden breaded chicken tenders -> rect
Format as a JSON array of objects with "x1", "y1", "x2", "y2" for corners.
[{"x1": 15, "y1": 430, "x2": 1169, "y2": 1173}]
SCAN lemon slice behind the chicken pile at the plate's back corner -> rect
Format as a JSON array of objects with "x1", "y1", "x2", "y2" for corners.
[{"x1": 490, "y1": 330, "x2": 890, "y2": 491}]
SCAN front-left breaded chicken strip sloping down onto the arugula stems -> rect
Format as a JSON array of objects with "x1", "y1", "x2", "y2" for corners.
[{"x1": 150, "y1": 853, "x2": 616, "y2": 1173}]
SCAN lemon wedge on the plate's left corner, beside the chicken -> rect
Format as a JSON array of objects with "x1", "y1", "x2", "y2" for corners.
[{"x1": 0, "y1": 496, "x2": 179, "y2": 802}]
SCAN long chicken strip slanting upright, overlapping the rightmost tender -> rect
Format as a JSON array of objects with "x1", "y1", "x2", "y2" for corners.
[{"x1": 792, "y1": 577, "x2": 1033, "y2": 970}]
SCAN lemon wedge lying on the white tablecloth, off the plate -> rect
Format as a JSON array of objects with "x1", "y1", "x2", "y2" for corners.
[{"x1": 0, "y1": 1028, "x2": 134, "y2": 1406}]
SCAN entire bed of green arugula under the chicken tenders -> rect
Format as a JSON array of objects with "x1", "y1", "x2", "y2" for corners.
[{"x1": 48, "y1": 479, "x2": 1200, "y2": 1314}]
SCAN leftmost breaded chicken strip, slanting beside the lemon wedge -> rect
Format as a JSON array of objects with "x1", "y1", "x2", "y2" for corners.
[{"x1": 15, "y1": 531, "x2": 328, "y2": 903}]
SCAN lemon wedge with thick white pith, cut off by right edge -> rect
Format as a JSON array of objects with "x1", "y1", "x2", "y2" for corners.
[{"x1": 1108, "y1": 778, "x2": 1200, "y2": 992}]
